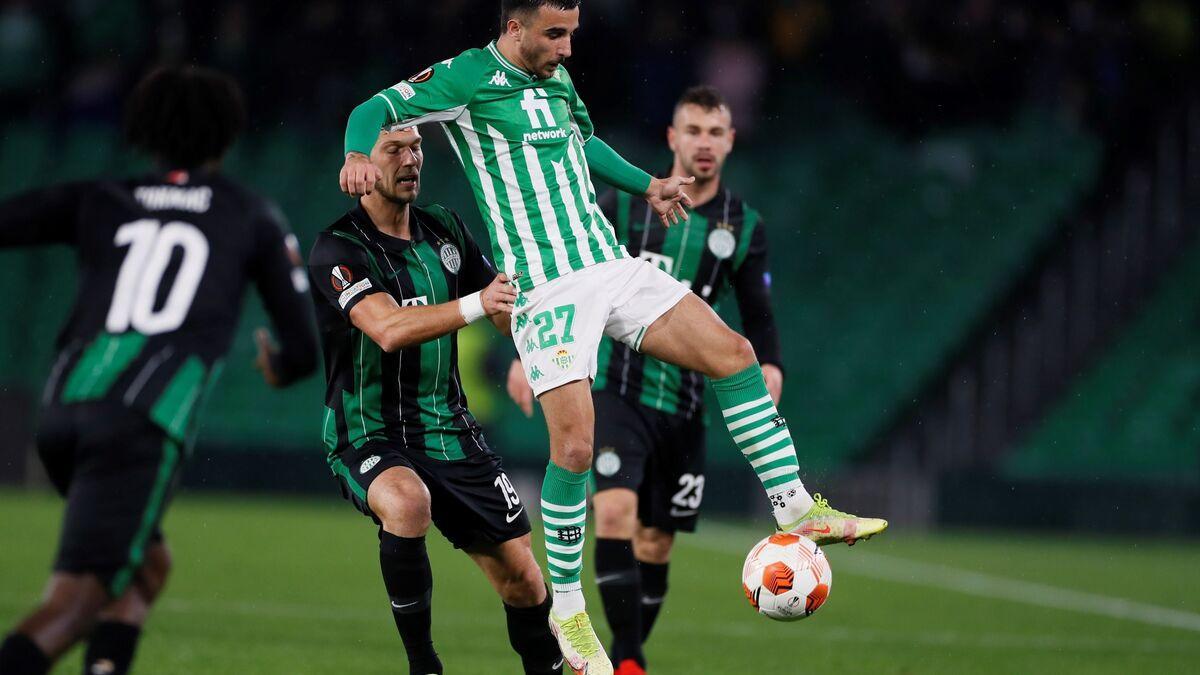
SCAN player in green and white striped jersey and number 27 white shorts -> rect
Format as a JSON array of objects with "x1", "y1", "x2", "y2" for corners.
[{"x1": 341, "y1": 0, "x2": 887, "y2": 675}]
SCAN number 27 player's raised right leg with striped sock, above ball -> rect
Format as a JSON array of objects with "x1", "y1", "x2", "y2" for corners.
[{"x1": 640, "y1": 294, "x2": 888, "y2": 544}]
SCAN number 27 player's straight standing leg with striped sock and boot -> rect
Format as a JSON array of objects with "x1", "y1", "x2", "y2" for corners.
[{"x1": 539, "y1": 380, "x2": 612, "y2": 675}]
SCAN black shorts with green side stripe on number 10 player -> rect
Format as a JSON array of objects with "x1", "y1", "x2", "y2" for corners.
[{"x1": 37, "y1": 401, "x2": 186, "y2": 597}]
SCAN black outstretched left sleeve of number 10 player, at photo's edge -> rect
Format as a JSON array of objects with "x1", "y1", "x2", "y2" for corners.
[{"x1": 0, "y1": 183, "x2": 86, "y2": 249}]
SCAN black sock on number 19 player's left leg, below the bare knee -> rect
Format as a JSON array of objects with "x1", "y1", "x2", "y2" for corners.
[{"x1": 379, "y1": 532, "x2": 442, "y2": 675}]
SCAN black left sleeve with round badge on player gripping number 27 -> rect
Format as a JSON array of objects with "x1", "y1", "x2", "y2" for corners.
[{"x1": 308, "y1": 232, "x2": 388, "y2": 323}]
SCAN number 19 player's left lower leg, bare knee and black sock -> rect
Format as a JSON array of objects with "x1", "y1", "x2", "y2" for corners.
[{"x1": 367, "y1": 466, "x2": 442, "y2": 675}]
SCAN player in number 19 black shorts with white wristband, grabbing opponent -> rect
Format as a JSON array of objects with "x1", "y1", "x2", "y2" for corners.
[{"x1": 308, "y1": 127, "x2": 563, "y2": 674}]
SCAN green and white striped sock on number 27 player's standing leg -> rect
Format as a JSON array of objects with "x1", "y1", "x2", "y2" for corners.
[{"x1": 541, "y1": 462, "x2": 592, "y2": 619}]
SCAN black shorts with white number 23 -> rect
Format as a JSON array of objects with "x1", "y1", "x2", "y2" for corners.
[{"x1": 592, "y1": 392, "x2": 706, "y2": 532}]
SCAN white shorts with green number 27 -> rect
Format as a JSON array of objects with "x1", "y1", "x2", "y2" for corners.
[{"x1": 512, "y1": 258, "x2": 691, "y2": 396}]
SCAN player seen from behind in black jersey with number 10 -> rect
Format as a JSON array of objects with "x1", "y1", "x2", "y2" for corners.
[{"x1": 0, "y1": 68, "x2": 317, "y2": 675}]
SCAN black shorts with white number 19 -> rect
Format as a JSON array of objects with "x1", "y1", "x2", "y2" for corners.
[{"x1": 331, "y1": 434, "x2": 529, "y2": 549}]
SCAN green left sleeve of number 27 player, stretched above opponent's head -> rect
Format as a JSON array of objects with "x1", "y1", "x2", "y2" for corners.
[{"x1": 346, "y1": 54, "x2": 480, "y2": 155}]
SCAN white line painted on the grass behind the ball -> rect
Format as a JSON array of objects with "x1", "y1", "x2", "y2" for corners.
[{"x1": 682, "y1": 528, "x2": 1200, "y2": 633}]
